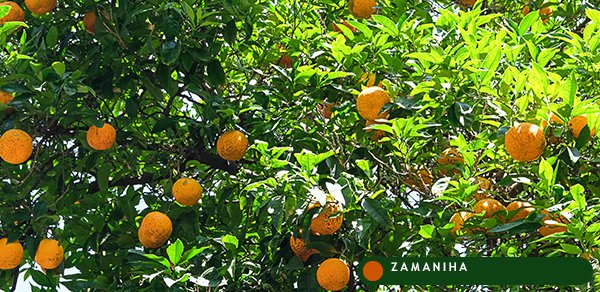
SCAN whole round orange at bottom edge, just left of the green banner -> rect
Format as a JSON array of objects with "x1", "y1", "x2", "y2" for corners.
[{"x1": 317, "y1": 258, "x2": 350, "y2": 291}]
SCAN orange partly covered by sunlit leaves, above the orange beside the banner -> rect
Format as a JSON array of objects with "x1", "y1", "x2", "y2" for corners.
[{"x1": 308, "y1": 196, "x2": 344, "y2": 235}]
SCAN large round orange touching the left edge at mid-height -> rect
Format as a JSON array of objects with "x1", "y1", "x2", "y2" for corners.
[{"x1": 0, "y1": 129, "x2": 33, "y2": 164}]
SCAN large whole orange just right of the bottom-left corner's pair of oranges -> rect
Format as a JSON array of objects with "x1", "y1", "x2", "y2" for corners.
[{"x1": 138, "y1": 211, "x2": 173, "y2": 248}]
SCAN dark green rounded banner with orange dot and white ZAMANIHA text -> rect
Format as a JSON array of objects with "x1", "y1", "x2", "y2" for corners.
[{"x1": 358, "y1": 257, "x2": 593, "y2": 285}]
